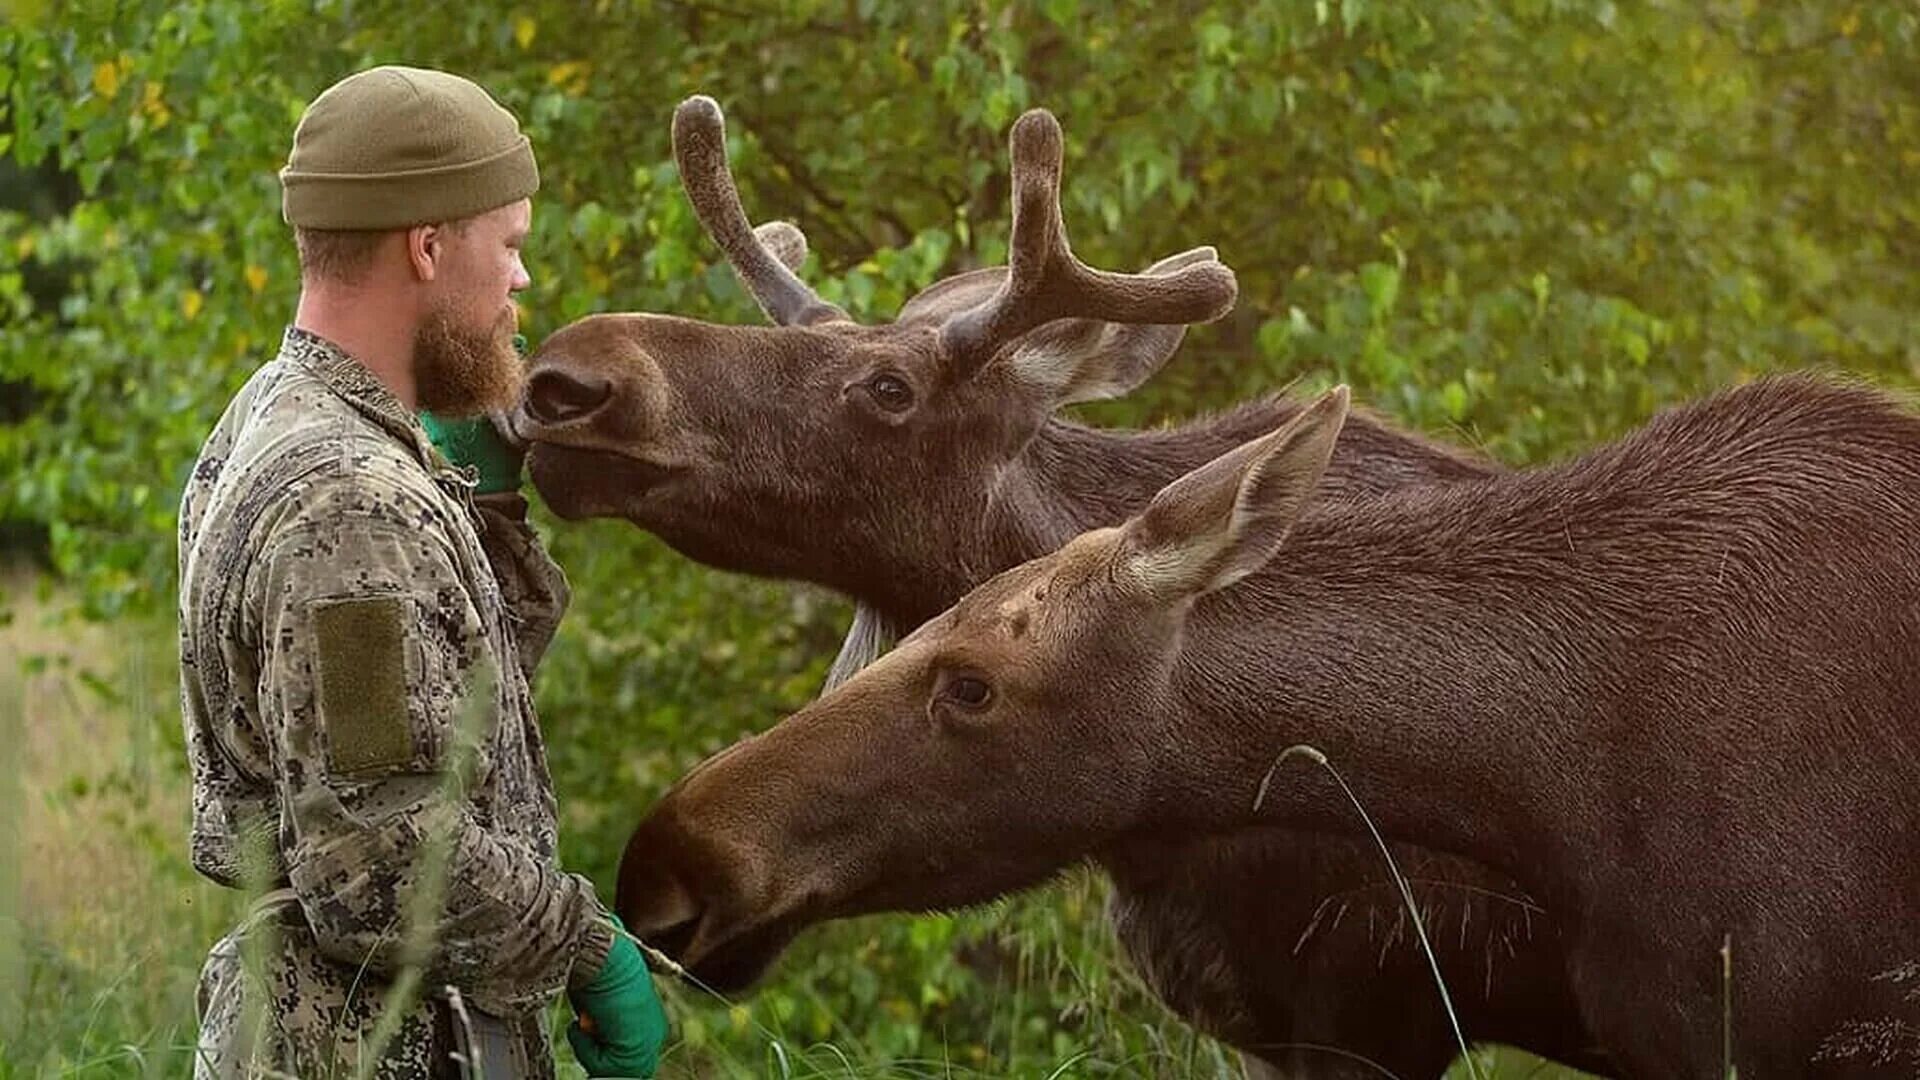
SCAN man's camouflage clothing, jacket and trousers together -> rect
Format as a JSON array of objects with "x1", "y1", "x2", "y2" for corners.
[{"x1": 180, "y1": 329, "x2": 612, "y2": 1076}]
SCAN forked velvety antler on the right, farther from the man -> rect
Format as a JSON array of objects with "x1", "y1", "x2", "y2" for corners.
[{"x1": 941, "y1": 110, "x2": 1238, "y2": 363}]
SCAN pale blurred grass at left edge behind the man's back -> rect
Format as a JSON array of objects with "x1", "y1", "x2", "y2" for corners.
[{"x1": 0, "y1": 577, "x2": 238, "y2": 1076}]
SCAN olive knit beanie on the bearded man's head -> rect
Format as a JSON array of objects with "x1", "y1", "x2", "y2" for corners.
[{"x1": 280, "y1": 67, "x2": 540, "y2": 229}]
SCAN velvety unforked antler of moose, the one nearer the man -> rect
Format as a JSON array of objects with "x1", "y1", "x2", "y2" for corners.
[{"x1": 674, "y1": 94, "x2": 847, "y2": 327}]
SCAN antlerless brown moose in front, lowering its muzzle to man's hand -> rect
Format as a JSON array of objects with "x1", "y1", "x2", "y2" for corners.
[{"x1": 620, "y1": 379, "x2": 1920, "y2": 1078}]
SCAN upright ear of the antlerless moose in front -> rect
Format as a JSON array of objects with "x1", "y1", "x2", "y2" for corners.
[{"x1": 1121, "y1": 386, "x2": 1348, "y2": 600}]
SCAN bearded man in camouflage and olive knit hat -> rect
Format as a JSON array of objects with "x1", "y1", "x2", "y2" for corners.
[{"x1": 180, "y1": 67, "x2": 666, "y2": 1078}]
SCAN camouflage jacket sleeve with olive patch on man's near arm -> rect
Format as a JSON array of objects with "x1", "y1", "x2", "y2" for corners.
[{"x1": 253, "y1": 507, "x2": 612, "y2": 1013}]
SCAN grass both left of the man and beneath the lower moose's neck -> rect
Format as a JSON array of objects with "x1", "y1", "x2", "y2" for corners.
[{"x1": 0, "y1": 575, "x2": 1578, "y2": 1080}]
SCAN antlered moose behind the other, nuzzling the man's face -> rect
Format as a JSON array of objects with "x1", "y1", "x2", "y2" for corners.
[{"x1": 515, "y1": 98, "x2": 1599, "y2": 1078}]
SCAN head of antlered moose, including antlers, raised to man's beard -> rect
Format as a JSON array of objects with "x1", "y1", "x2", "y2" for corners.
[{"x1": 511, "y1": 98, "x2": 1235, "y2": 619}]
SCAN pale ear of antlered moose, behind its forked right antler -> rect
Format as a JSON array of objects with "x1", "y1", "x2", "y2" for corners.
[{"x1": 1006, "y1": 248, "x2": 1219, "y2": 405}]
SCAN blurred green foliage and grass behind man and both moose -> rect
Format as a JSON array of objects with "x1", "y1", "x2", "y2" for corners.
[{"x1": 0, "y1": 0, "x2": 1920, "y2": 1076}]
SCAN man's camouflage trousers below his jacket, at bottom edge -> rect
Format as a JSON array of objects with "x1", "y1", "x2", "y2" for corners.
[{"x1": 194, "y1": 891, "x2": 553, "y2": 1080}]
